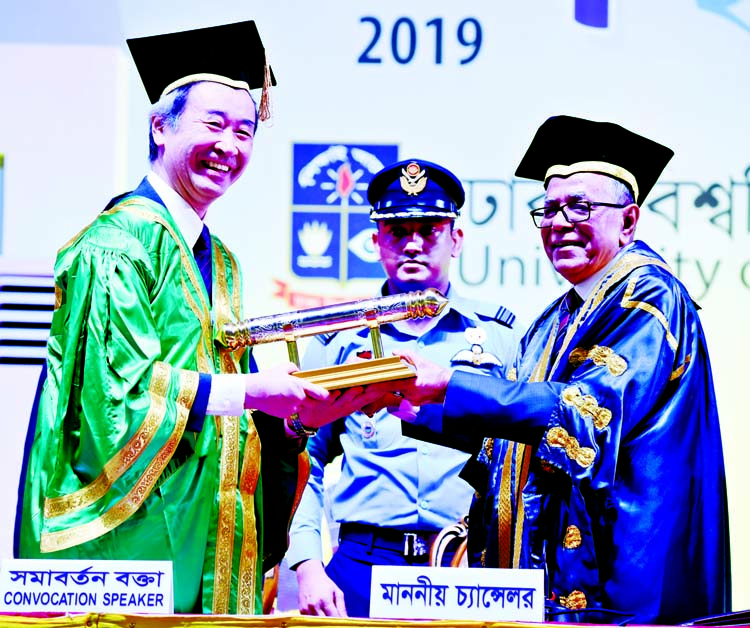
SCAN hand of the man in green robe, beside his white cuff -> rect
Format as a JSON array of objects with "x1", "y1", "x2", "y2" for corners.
[{"x1": 245, "y1": 362, "x2": 330, "y2": 418}]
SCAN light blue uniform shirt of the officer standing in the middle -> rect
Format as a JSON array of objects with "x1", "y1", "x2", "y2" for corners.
[{"x1": 287, "y1": 289, "x2": 518, "y2": 566}]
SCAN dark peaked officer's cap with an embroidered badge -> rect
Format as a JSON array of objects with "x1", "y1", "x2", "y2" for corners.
[{"x1": 367, "y1": 159, "x2": 465, "y2": 220}]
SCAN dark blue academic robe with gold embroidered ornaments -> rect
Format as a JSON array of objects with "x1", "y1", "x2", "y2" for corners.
[{"x1": 417, "y1": 242, "x2": 731, "y2": 624}]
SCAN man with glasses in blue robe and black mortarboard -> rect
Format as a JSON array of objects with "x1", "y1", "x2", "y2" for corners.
[{"x1": 401, "y1": 116, "x2": 731, "y2": 624}]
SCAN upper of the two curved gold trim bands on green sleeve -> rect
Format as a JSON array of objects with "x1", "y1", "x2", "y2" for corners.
[{"x1": 44, "y1": 362, "x2": 170, "y2": 519}]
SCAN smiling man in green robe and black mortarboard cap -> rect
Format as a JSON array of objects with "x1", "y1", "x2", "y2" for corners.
[{"x1": 16, "y1": 22, "x2": 358, "y2": 614}]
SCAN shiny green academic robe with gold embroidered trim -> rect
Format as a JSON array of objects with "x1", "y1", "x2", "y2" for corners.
[{"x1": 19, "y1": 195, "x2": 309, "y2": 614}]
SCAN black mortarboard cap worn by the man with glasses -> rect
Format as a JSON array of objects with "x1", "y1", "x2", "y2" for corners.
[{"x1": 516, "y1": 116, "x2": 674, "y2": 204}]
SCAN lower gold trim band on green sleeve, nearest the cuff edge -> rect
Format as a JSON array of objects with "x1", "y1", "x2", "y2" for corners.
[{"x1": 40, "y1": 371, "x2": 198, "y2": 553}]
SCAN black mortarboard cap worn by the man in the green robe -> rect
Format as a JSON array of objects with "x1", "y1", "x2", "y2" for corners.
[{"x1": 127, "y1": 20, "x2": 276, "y2": 119}]
